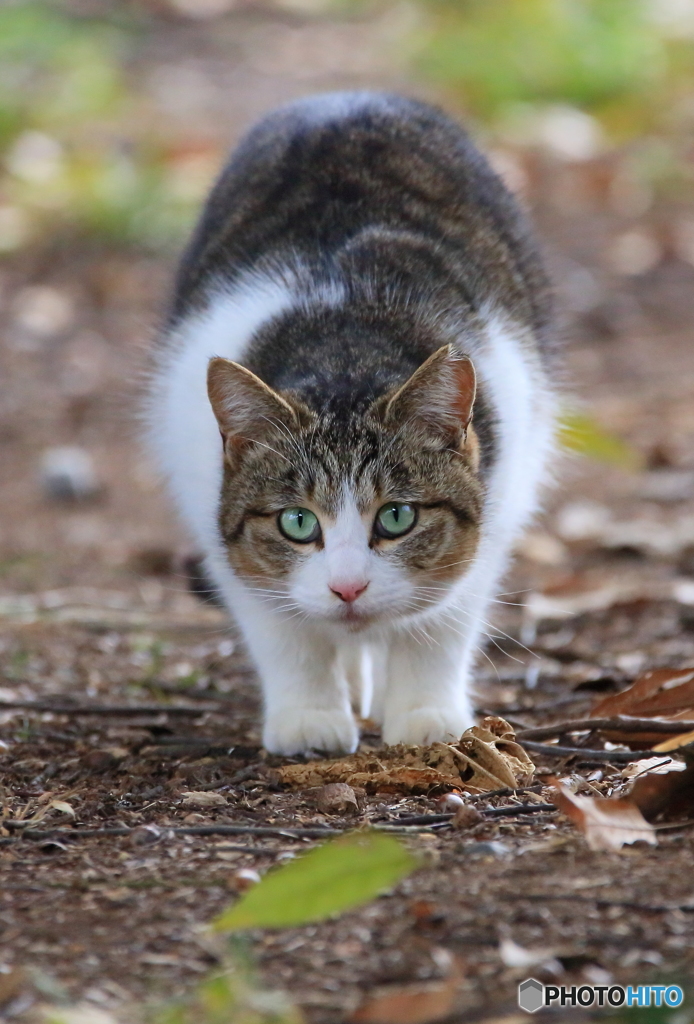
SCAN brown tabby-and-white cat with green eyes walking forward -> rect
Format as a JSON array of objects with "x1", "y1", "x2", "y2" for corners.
[{"x1": 149, "y1": 92, "x2": 556, "y2": 755}]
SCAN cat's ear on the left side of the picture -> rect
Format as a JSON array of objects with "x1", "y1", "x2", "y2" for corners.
[{"x1": 207, "y1": 358, "x2": 300, "y2": 466}]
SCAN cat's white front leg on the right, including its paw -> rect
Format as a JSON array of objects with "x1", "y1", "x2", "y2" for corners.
[{"x1": 383, "y1": 623, "x2": 475, "y2": 745}]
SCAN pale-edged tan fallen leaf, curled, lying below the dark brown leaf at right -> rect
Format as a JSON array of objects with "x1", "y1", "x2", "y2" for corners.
[{"x1": 552, "y1": 783, "x2": 657, "y2": 850}]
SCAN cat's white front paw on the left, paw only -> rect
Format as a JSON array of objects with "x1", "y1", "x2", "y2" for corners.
[{"x1": 263, "y1": 708, "x2": 359, "y2": 756}]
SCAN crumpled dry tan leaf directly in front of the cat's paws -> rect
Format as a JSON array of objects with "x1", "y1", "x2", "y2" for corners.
[{"x1": 274, "y1": 717, "x2": 534, "y2": 794}]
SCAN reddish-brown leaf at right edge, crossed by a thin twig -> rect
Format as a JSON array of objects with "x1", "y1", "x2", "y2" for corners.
[{"x1": 591, "y1": 667, "x2": 694, "y2": 750}]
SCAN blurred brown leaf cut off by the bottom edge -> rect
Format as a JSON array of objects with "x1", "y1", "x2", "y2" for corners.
[{"x1": 349, "y1": 966, "x2": 462, "y2": 1024}]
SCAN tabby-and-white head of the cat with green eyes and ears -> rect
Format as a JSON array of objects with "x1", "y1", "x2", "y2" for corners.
[{"x1": 208, "y1": 346, "x2": 483, "y2": 630}]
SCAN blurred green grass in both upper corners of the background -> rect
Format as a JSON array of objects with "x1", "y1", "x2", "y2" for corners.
[{"x1": 0, "y1": 0, "x2": 694, "y2": 252}]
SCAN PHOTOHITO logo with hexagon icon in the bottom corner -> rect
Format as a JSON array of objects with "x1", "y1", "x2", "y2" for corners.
[{"x1": 518, "y1": 978, "x2": 685, "y2": 1014}]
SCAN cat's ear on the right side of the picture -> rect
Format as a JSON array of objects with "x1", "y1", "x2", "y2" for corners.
[{"x1": 384, "y1": 345, "x2": 477, "y2": 444}]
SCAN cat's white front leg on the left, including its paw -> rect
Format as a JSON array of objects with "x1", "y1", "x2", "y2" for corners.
[{"x1": 241, "y1": 609, "x2": 359, "y2": 756}]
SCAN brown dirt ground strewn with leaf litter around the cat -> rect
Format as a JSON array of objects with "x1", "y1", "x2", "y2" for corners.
[{"x1": 0, "y1": 2, "x2": 694, "y2": 1024}]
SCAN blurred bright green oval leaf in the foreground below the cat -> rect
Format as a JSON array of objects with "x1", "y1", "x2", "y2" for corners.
[{"x1": 213, "y1": 833, "x2": 418, "y2": 932}]
